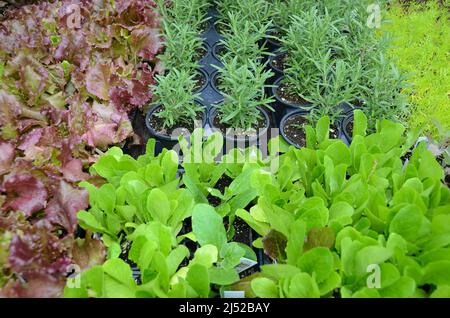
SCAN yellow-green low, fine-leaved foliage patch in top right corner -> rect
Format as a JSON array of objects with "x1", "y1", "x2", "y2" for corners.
[{"x1": 383, "y1": 1, "x2": 450, "y2": 137}]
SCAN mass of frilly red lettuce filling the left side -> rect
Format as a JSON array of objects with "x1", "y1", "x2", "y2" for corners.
[{"x1": 0, "y1": 0, "x2": 162, "y2": 297}]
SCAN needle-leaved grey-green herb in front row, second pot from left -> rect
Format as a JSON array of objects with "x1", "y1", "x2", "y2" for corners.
[{"x1": 217, "y1": 58, "x2": 274, "y2": 130}]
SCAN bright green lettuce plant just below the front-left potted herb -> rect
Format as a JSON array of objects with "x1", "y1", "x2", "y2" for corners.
[{"x1": 77, "y1": 140, "x2": 194, "y2": 252}]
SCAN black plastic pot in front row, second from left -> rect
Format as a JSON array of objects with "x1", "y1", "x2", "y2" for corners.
[{"x1": 208, "y1": 104, "x2": 270, "y2": 153}]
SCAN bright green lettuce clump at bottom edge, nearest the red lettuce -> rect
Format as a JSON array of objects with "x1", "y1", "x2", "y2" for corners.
[{"x1": 64, "y1": 222, "x2": 210, "y2": 298}]
